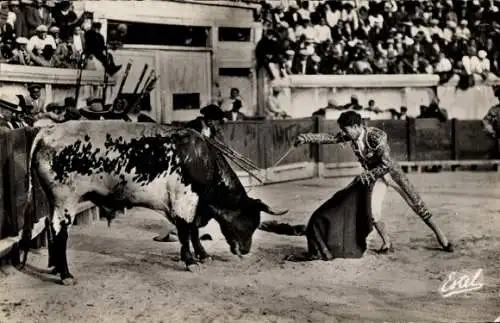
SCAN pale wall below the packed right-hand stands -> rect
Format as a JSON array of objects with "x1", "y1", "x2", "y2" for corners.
[{"x1": 261, "y1": 74, "x2": 500, "y2": 120}]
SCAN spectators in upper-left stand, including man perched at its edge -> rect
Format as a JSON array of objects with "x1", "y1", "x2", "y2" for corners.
[{"x1": 0, "y1": 0, "x2": 121, "y2": 75}]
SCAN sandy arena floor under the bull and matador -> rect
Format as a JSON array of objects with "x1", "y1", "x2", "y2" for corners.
[{"x1": 0, "y1": 172, "x2": 500, "y2": 323}]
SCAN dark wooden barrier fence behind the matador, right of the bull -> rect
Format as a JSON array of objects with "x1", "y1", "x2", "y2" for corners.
[{"x1": 220, "y1": 117, "x2": 500, "y2": 185}]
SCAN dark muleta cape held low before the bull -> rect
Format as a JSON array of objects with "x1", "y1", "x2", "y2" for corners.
[{"x1": 259, "y1": 181, "x2": 373, "y2": 261}]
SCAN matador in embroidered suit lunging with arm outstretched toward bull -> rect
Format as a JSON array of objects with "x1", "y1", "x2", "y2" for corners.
[{"x1": 294, "y1": 111, "x2": 453, "y2": 253}]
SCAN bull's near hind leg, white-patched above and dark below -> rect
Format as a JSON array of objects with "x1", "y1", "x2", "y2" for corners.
[{"x1": 49, "y1": 207, "x2": 75, "y2": 285}]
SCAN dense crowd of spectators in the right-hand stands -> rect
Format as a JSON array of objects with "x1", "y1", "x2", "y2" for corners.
[{"x1": 256, "y1": 0, "x2": 500, "y2": 86}]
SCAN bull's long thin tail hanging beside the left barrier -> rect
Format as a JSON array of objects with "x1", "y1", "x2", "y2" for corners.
[{"x1": 18, "y1": 128, "x2": 43, "y2": 268}]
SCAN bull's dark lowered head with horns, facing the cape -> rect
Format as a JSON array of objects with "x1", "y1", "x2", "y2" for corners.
[{"x1": 212, "y1": 197, "x2": 288, "y2": 256}]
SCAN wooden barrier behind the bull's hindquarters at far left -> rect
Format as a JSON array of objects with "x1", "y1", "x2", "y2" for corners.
[{"x1": 0, "y1": 128, "x2": 99, "y2": 266}]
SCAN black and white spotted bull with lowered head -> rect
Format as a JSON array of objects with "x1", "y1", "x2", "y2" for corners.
[{"x1": 21, "y1": 121, "x2": 287, "y2": 284}]
